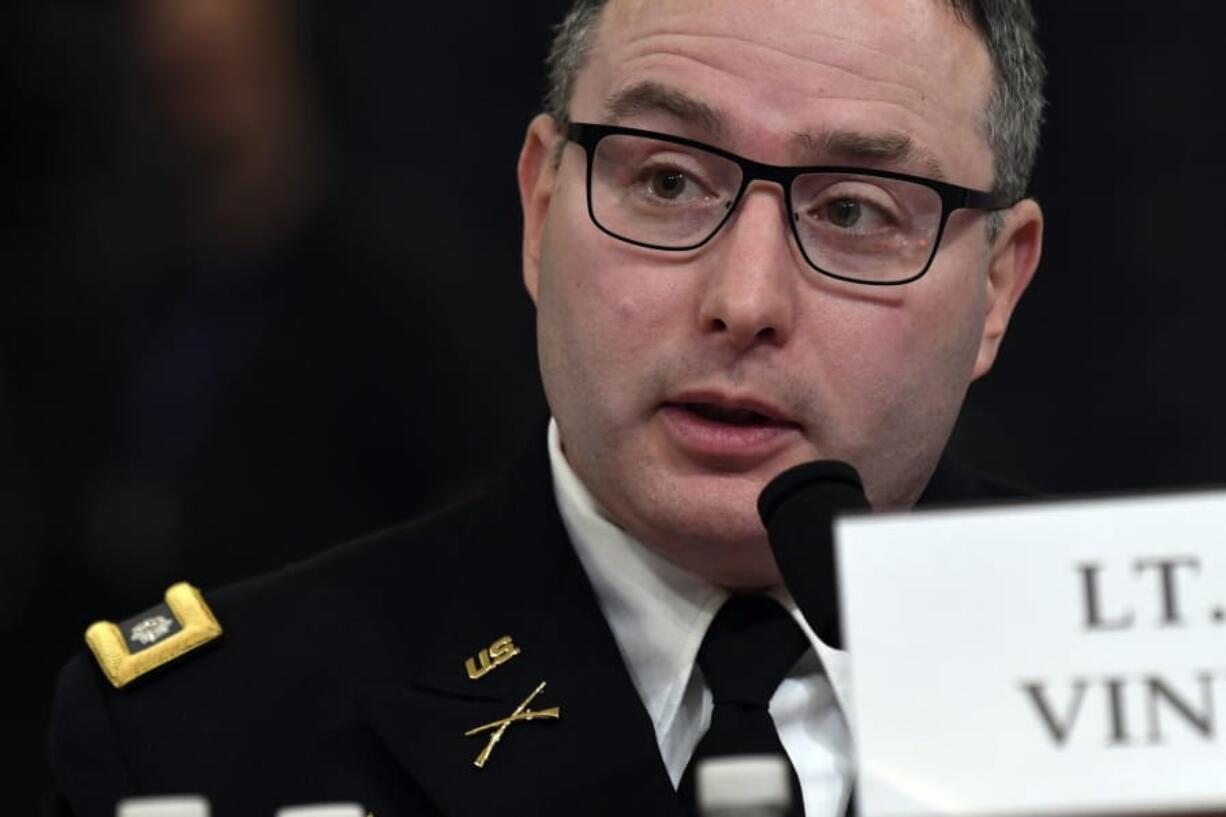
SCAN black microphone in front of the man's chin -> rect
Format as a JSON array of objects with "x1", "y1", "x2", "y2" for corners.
[{"x1": 758, "y1": 460, "x2": 868, "y2": 649}]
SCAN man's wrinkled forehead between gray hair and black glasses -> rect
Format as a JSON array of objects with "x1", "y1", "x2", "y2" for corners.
[{"x1": 580, "y1": 0, "x2": 992, "y2": 175}]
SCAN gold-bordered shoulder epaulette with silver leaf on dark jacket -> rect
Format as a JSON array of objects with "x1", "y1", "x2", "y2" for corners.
[{"x1": 85, "y1": 581, "x2": 222, "y2": 689}]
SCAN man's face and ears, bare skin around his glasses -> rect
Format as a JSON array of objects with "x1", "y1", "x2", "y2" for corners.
[{"x1": 520, "y1": 0, "x2": 1041, "y2": 586}]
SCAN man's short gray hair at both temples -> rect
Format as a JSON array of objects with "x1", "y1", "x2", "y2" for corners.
[{"x1": 544, "y1": 0, "x2": 1046, "y2": 199}]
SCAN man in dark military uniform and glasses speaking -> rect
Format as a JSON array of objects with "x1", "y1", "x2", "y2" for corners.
[{"x1": 51, "y1": 0, "x2": 1042, "y2": 815}]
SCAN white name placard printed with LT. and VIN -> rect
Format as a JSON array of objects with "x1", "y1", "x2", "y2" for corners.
[{"x1": 835, "y1": 492, "x2": 1226, "y2": 817}]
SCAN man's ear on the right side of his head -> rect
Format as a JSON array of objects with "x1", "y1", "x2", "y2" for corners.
[{"x1": 971, "y1": 199, "x2": 1043, "y2": 380}]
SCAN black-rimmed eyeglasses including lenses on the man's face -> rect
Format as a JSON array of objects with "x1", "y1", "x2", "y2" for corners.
[{"x1": 566, "y1": 123, "x2": 1014, "y2": 286}]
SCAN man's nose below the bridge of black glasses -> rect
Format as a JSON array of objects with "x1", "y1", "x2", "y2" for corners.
[{"x1": 699, "y1": 183, "x2": 799, "y2": 350}]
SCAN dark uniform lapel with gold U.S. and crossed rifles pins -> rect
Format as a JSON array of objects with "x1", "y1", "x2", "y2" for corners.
[{"x1": 359, "y1": 440, "x2": 680, "y2": 817}]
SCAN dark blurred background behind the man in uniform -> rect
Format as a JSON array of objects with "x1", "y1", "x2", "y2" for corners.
[{"x1": 7, "y1": 0, "x2": 1226, "y2": 813}]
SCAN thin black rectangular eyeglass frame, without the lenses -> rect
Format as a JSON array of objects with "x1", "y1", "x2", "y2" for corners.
[{"x1": 566, "y1": 121, "x2": 1018, "y2": 287}]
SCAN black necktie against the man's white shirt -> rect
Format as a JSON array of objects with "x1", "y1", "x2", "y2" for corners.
[{"x1": 678, "y1": 596, "x2": 809, "y2": 817}]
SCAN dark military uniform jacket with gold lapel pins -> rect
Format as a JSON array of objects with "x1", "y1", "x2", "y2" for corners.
[{"x1": 50, "y1": 429, "x2": 1020, "y2": 817}]
